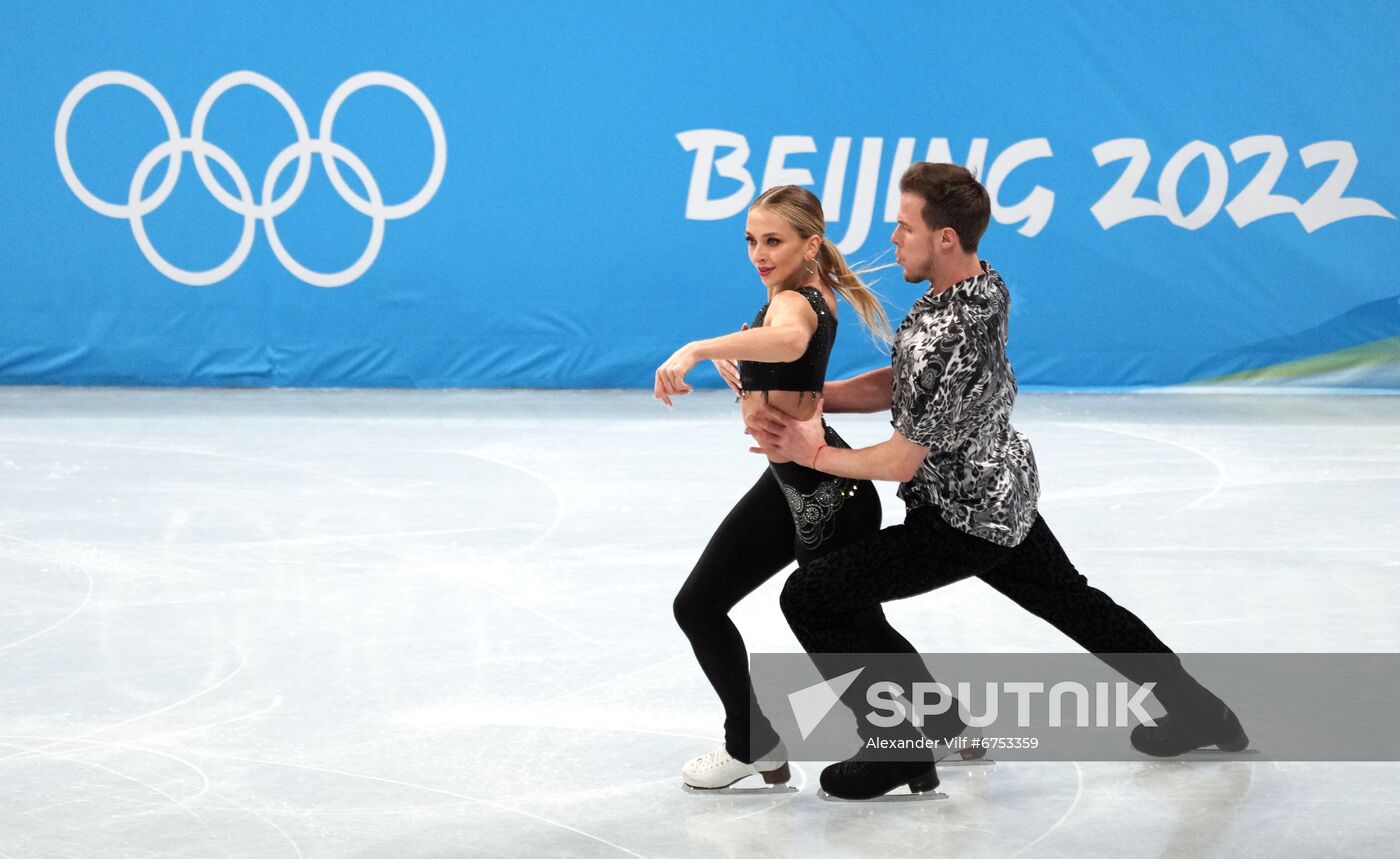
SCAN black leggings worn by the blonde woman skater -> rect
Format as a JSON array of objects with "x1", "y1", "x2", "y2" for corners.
[{"x1": 673, "y1": 427, "x2": 879, "y2": 762}]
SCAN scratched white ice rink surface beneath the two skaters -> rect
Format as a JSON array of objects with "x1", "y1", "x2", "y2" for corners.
[{"x1": 0, "y1": 388, "x2": 1400, "y2": 859}]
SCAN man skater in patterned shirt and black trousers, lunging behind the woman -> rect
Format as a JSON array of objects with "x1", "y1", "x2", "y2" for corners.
[{"x1": 748, "y1": 162, "x2": 1249, "y2": 799}]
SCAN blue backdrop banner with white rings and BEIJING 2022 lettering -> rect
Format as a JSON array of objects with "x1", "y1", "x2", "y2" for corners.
[{"x1": 0, "y1": 0, "x2": 1400, "y2": 388}]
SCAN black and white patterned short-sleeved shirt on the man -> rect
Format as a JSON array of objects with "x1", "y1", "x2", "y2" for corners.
[{"x1": 890, "y1": 263, "x2": 1040, "y2": 546}]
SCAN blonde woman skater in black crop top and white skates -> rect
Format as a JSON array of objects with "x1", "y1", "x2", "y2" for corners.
[{"x1": 654, "y1": 185, "x2": 896, "y2": 789}]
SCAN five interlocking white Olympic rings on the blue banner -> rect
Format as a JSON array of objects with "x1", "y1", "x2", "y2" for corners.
[{"x1": 53, "y1": 71, "x2": 447, "y2": 287}]
